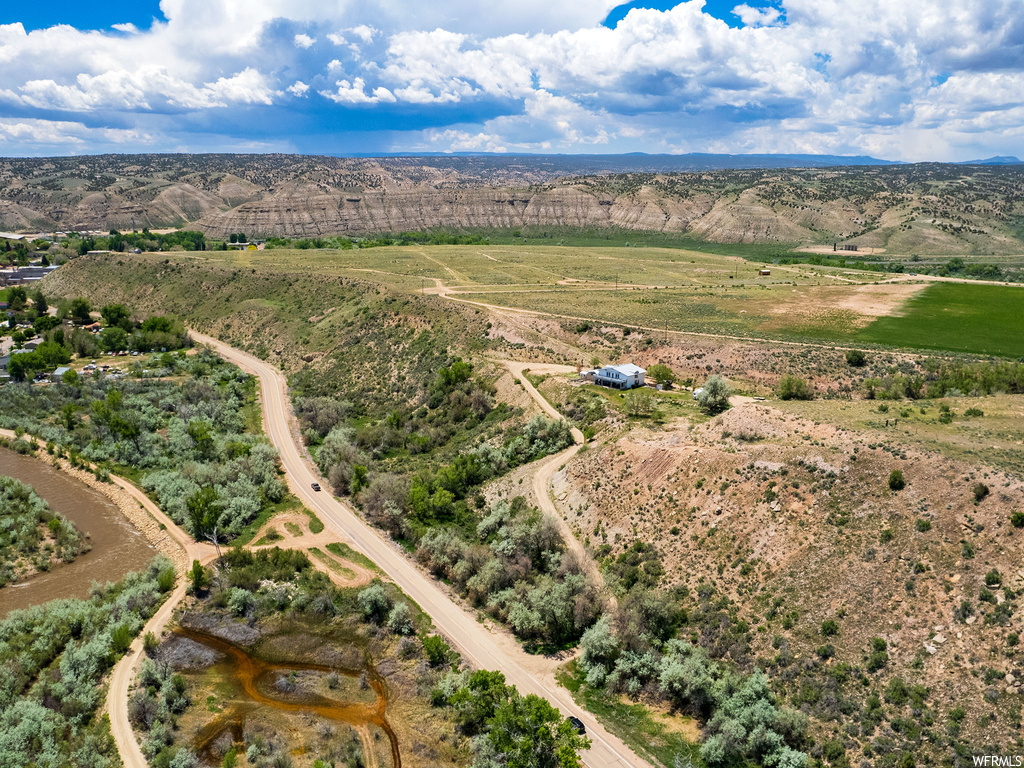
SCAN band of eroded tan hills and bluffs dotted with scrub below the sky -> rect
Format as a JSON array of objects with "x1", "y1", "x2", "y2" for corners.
[{"x1": 6, "y1": 155, "x2": 1024, "y2": 254}]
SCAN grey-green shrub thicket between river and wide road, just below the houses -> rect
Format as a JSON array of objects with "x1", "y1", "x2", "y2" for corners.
[{"x1": 0, "y1": 351, "x2": 286, "y2": 538}]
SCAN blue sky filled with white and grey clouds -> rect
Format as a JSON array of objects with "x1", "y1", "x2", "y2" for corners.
[{"x1": 0, "y1": 0, "x2": 1024, "y2": 161}]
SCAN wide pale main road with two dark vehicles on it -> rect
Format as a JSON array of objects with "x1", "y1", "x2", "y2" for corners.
[{"x1": 191, "y1": 332, "x2": 649, "y2": 768}]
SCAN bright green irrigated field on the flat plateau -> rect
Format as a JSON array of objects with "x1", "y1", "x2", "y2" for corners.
[{"x1": 856, "y1": 283, "x2": 1024, "y2": 357}]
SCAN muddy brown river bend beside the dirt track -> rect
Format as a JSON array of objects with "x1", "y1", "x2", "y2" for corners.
[{"x1": 0, "y1": 447, "x2": 157, "y2": 617}]
